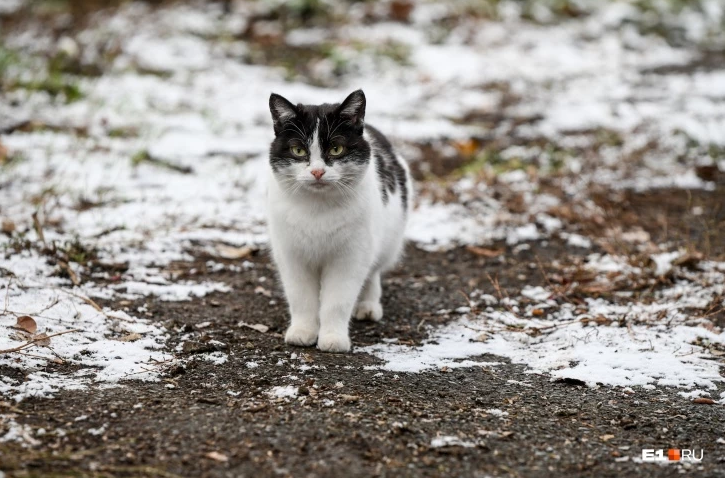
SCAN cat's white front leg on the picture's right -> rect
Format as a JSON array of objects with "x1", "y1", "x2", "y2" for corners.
[{"x1": 317, "y1": 257, "x2": 368, "y2": 352}]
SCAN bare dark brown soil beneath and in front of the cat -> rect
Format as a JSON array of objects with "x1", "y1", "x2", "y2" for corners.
[{"x1": 0, "y1": 188, "x2": 725, "y2": 477}]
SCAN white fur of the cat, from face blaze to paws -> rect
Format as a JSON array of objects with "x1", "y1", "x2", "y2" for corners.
[{"x1": 268, "y1": 126, "x2": 412, "y2": 352}]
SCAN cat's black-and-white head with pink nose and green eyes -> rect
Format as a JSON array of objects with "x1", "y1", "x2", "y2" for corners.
[{"x1": 269, "y1": 90, "x2": 370, "y2": 196}]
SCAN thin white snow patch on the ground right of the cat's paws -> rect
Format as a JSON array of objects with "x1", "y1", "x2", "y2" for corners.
[{"x1": 361, "y1": 254, "x2": 725, "y2": 390}]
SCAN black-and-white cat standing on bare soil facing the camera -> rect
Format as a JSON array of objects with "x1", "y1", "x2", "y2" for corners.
[{"x1": 267, "y1": 90, "x2": 413, "y2": 352}]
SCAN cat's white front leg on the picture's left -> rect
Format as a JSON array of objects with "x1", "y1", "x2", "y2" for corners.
[{"x1": 278, "y1": 257, "x2": 320, "y2": 346}]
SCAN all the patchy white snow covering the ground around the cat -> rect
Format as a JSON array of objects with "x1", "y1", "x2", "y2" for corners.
[{"x1": 0, "y1": 0, "x2": 725, "y2": 400}]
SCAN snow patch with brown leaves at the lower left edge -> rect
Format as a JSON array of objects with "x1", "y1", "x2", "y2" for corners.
[{"x1": 0, "y1": 252, "x2": 170, "y2": 400}]
